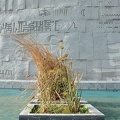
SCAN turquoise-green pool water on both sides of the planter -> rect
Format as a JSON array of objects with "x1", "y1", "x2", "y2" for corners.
[{"x1": 0, "y1": 89, "x2": 120, "y2": 120}]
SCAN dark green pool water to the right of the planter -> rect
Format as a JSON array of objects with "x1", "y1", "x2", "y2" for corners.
[{"x1": 82, "y1": 91, "x2": 120, "y2": 120}]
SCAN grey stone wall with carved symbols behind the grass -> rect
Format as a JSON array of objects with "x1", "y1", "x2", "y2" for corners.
[{"x1": 0, "y1": 0, "x2": 120, "y2": 81}]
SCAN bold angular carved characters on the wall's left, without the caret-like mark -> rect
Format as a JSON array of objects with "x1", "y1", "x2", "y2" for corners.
[{"x1": 0, "y1": 20, "x2": 59, "y2": 34}]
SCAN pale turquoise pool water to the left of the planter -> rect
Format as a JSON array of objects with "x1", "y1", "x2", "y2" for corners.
[{"x1": 0, "y1": 89, "x2": 33, "y2": 120}]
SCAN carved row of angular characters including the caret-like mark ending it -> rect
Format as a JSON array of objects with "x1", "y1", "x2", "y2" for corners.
[{"x1": 0, "y1": 20, "x2": 77, "y2": 34}]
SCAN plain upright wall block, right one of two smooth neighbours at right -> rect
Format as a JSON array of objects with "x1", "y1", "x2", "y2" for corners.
[{"x1": 93, "y1": 33, "x2": 107, "y2": 59}]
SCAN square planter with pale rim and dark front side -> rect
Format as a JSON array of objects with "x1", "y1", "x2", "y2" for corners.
[{"x1": 19, "y1": 104, "x2": 105, "y2": 120}]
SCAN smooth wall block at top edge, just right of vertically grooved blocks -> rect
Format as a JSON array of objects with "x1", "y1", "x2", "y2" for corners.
[{"x1": 26, "y1": 0, "x2": 39, "y2": 9}]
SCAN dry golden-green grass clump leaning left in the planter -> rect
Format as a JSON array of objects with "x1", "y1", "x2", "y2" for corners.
[{"x1": 12, "y1": 35, "x2": 87, "y2": 113}]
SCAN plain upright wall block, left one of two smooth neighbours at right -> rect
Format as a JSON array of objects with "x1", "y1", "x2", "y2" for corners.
[{"x1": 79, "y1": 33, "x2": 93, "y2": 59}]
